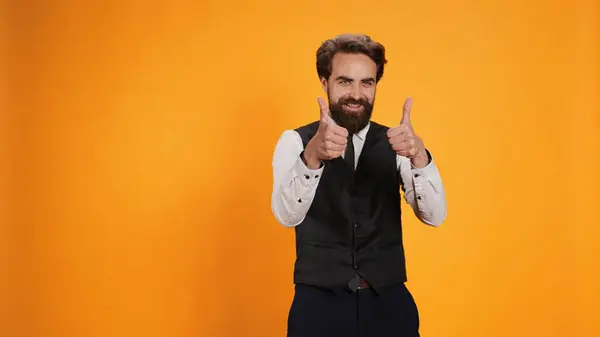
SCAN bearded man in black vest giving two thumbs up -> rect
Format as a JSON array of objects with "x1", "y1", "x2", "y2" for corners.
[{"x1": 272, "y1": 34, "x2": 446, "y2": 337}]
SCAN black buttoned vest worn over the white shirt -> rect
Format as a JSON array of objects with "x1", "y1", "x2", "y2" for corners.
[{"x1": 294, "y1": 121, "x2": 406, "y2": 289}]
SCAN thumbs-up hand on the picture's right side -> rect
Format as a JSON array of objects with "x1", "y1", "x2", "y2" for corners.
[{"x1": 387, "y1": 97, "x2": 429, "y2": 168}]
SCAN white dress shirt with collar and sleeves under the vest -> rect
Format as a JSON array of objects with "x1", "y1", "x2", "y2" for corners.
[{"x1": 271, "y1": 124, "x2": 446, "y2": 227}]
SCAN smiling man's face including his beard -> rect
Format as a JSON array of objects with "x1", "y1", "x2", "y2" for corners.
[{"x1": 322, "y1": 53, "x2": 377, "y2": 133}]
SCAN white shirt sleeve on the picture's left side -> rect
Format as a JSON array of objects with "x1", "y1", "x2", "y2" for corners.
[{"x1": 271, "y1": 130, "x2": 323, "y2": 227}]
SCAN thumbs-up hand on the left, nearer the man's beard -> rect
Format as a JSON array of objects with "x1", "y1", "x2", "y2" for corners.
[{"x1": 303, "y1": 97, "x2": 348, "y2": 170}]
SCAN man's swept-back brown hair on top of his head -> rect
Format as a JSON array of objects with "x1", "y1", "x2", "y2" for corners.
[{"x1": 317, "y1": 34, "x2": 387, "y2": 82}]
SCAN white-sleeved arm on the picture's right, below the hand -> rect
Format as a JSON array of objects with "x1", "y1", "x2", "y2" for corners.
[{"x1": 397, "y1": 152, "x2": 447, "y2": 227}]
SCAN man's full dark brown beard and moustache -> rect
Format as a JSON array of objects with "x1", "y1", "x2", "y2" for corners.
[{"x1": 329, "y1": 93, "x2": 374, "y2": 134}]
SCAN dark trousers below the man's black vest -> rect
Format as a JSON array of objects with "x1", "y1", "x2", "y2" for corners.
[{"x1": 287, "y1": 284, "x2": 419, "y2": 337}]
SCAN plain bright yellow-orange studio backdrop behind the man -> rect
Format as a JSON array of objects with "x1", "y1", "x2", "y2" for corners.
[{"x1": 0, "y1": 0, "x2": 600, "y2": 337}]
